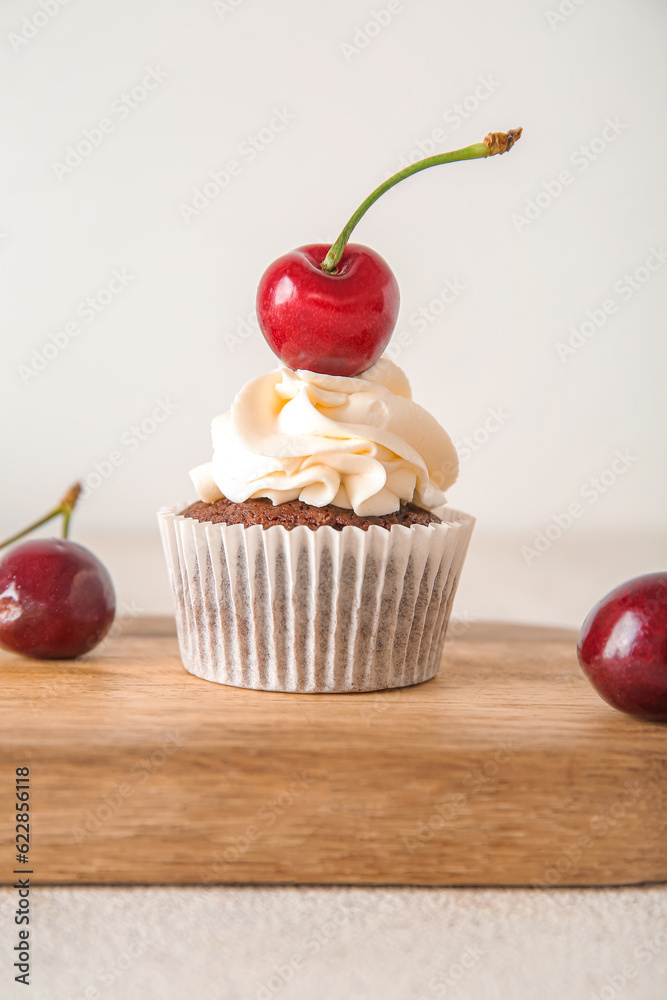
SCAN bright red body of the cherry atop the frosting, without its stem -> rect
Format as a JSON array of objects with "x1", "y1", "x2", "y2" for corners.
[{"x1": 257, "y1": 243, "x2": 400, "y2": 375}]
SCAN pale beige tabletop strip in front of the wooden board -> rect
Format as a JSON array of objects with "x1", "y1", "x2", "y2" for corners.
[{"x1": 0, "y1": 886, "x2": 667, "y2": 1000}]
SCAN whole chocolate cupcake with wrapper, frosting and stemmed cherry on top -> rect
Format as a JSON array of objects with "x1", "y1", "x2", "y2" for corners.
[{"x1": 159, "y1": 129, "x2": 521, "y2": 693}]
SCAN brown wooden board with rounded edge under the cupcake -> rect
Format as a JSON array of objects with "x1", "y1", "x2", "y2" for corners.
[{"x1": 0, "y1": 620, "x2": 667, "y2": 886}]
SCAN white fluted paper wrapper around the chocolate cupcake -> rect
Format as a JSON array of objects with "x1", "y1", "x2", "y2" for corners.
[{"x1": 158, "y1": 507, "x2": 475, "y2": 693}]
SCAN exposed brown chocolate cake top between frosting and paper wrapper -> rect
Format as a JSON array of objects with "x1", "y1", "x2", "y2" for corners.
[{"x1": 181, "y1": 497, "x2": 441, "y2": 531}]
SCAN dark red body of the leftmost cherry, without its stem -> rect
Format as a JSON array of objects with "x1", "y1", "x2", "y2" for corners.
[{"x1": 0, "y1": 538, "x2": 116, "y2": 660}]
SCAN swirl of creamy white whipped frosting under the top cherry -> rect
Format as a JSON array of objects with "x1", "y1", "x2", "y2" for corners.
[{"x1": 190, "y1": 357, "x2": 458, "y2": 516}]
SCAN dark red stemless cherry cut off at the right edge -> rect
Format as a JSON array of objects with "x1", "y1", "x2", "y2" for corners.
[{"x1": 577, "y1": 573, "x2": 667, "y2": 722}]
